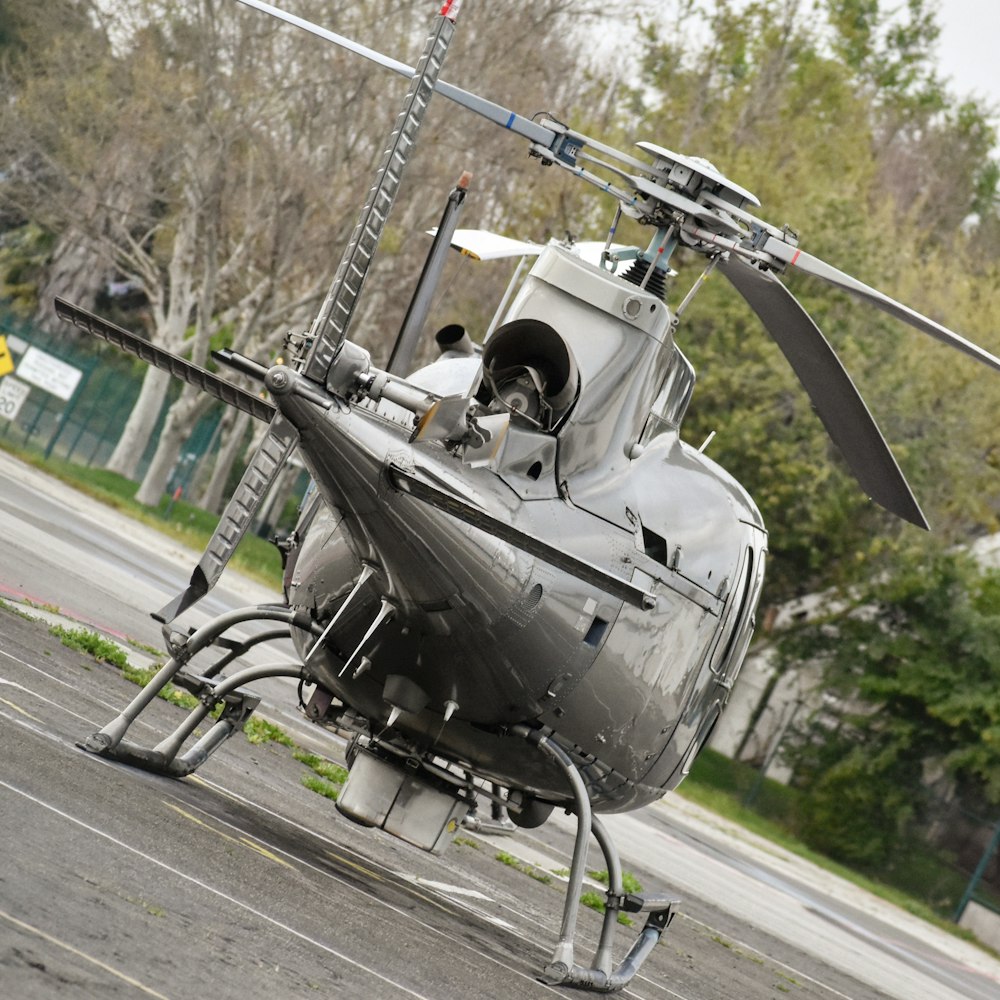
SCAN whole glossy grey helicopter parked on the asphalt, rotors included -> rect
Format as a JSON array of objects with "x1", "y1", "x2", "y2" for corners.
[{"x1": 56, "y1": 0, "x2": 1000, "y2": 992}]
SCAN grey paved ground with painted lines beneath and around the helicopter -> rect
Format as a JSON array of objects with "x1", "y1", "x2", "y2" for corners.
[{"x1": 0, "y1": 454, "x2": 1000, "y2": 1000}]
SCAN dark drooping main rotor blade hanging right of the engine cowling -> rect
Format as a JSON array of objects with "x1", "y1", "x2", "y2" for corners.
[{"x1": 718, "y1": 256, "x2": 929, "y2": 529}]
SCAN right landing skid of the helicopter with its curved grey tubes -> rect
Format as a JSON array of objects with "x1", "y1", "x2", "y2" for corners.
[{"x1": 511, "y1": 726, "x2": 680, "y2": 993}]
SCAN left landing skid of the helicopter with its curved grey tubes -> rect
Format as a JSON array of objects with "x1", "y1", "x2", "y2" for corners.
[{"x1": 77, "y1": 604, "x2": 319, "y2": 778}]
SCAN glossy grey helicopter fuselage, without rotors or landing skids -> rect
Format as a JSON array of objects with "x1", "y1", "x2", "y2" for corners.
[{"x1": 279, "y1": 247, "x2": 766, "y2": 810}]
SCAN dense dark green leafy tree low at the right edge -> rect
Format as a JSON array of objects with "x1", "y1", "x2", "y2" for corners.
[{"x1": 777, "y1": 546, "x2": 1000, "y2": 867}]
